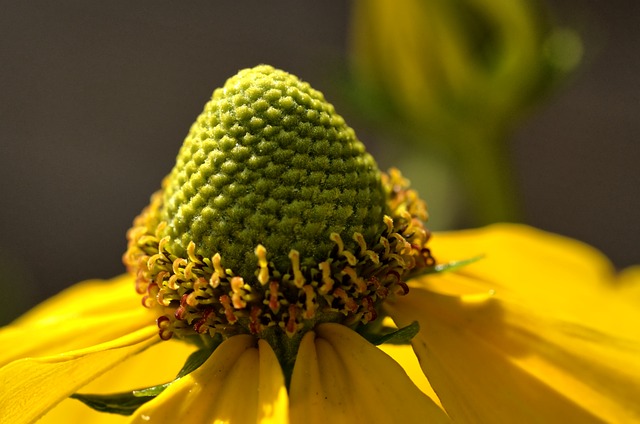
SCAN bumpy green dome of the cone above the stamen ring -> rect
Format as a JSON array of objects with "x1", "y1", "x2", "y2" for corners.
[{"x1": 160, "y1": 66, "x2": 386, "y2": 281}]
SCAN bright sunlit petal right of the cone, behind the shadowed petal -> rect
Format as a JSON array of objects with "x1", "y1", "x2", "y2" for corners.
[{"x1": 424, "y1": 224, "x2": 614, "y2": 300}]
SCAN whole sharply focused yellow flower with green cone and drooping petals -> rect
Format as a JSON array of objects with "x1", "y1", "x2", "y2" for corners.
[{"x1": 0, "y1": 67, "x2": 640, "y2": 424}]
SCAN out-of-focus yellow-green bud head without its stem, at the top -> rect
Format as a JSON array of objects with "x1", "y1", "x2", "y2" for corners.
[{"x1": 351, "y1": 0, "x2": 580, "y2": 136}]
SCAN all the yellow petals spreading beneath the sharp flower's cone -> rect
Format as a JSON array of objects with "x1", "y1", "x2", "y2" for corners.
[{"x1": 0, "y1": 225, "x2": 640, "y2": 423}]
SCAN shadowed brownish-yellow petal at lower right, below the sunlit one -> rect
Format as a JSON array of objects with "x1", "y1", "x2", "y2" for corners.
[{"x1": 387, "y1": 275, "x2": 640, "y2": 423}]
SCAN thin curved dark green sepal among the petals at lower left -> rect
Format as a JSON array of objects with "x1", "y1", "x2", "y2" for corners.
[{"x1": 70, "y1": 337, "x2": 222, "y2": 415}]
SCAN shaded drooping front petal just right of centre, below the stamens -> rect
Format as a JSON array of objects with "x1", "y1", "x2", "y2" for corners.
[{"x1": 290, "y1": 324, "x2": 448, "y2": 424}]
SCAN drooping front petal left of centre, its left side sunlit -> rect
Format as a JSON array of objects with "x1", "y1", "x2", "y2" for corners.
[{"x1": 131, "y1": 335, "x2": 288, "y2": 424}]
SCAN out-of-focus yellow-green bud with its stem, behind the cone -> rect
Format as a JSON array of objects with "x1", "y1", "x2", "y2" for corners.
[{"x1": 349, "y1": 0, "x2": 582, "y2": 224}]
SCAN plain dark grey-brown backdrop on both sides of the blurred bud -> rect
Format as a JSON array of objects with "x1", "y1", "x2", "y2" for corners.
[{"x1": 0, "y1": 0, "x2": 640, "y2": 323}]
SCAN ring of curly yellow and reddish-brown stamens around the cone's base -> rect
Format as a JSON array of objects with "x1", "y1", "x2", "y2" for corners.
[{"x1": 123, "y1": 169, "x2": 435, "y2": 339}]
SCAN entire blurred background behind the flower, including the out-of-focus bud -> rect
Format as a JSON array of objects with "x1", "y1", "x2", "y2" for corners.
[{"x1": 0, "y1": 0, "x2": 640, "y2": 324}]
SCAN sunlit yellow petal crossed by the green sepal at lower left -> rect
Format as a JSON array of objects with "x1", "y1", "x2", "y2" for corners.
[{"x1": 38, "y1": 339, "x2": 196, "y2": 424}]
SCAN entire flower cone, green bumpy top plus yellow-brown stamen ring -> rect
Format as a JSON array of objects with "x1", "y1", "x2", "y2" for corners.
[{"x1": 124, "y1": 66, "x2": 434, "y2": 339}]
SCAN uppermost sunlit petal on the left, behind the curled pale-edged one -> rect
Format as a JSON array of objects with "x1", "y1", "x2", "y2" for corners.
[{"x1": 0, "y1": 276, "x2": 155, "y2": 366}]
